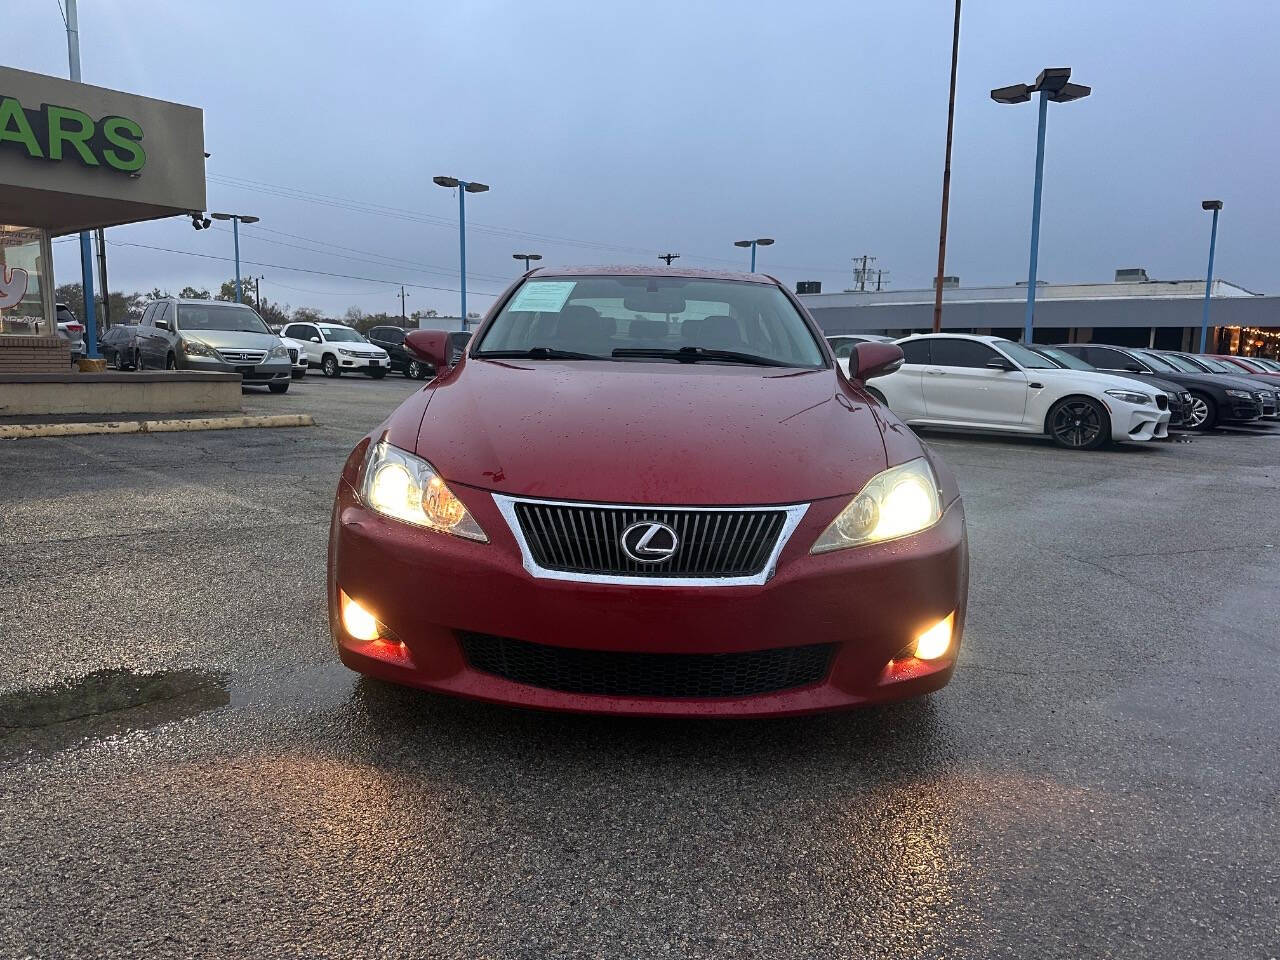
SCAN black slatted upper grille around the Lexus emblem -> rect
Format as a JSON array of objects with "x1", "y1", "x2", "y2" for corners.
[{"x1": 515, "y1": 500, "x2": 787, "y2": 580}]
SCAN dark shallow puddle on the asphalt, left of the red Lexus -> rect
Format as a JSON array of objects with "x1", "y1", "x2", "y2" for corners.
[{"x1": 0, "y1": 669, "x2": 230, "y2": 759}]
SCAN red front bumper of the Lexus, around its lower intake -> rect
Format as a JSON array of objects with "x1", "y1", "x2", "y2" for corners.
[{"x1": 328, "y1": 483, "x2": 968, "y2": 717}]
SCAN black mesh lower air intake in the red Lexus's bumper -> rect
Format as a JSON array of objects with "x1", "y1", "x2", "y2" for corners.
[{"x1": 458, "y1": 632, "x2": 835, "y2": 699}]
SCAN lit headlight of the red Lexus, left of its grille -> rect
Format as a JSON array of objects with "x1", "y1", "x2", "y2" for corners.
[{"x1": 361, "y1": 442, "x2": 489, "y2": 543}]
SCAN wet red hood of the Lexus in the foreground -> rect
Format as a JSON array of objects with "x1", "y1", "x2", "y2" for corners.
[{"x1": 409, "y1": 358, "x2": 890, "y2": 506}]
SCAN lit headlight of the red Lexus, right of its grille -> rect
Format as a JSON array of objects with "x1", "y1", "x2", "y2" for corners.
[{"x1": 810, "y1": 457, "x2": 942, "y2": 553}]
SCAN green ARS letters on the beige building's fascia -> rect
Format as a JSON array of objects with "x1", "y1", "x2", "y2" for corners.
[{"x1": 0, "y1": 95, "x2": 147, "y2": 174}]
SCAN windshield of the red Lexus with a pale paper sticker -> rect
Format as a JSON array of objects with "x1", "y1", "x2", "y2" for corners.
[{"x1": 472, "y1": 276, "x2": 826, "y2": 367}]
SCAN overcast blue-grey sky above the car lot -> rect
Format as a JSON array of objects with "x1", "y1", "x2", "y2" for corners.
[{"x1": 4, "y1": 0, "x2": 1280, "y2": 314}]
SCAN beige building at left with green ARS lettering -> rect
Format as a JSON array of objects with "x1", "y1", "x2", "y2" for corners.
[{"x1": 0, "y1": 67, "x2": 205, "y2": 374}]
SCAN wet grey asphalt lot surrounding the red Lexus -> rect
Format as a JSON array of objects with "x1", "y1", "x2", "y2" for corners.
[{"x1": 0, "y1": 378, "x2": 1280, "y2": 960}]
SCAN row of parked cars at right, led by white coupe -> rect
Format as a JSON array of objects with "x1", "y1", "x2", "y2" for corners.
[{"x1": 829, "y1": 334, "x2": 1280, "y2": 449}]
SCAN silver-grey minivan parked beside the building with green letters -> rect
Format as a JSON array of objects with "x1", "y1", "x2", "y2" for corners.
[{"x1": 137, "y1": 297, "x2": 292, "y2": 393}]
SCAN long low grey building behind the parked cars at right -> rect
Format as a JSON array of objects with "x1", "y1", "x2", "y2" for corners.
[{"x1": 799, "y1": 269, "x2": 1280, "y2": 357}]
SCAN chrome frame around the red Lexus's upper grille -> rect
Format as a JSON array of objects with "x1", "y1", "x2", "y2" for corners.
[{"x1": 493, "y1": 493, "x2": 809, "y2": 586}]
